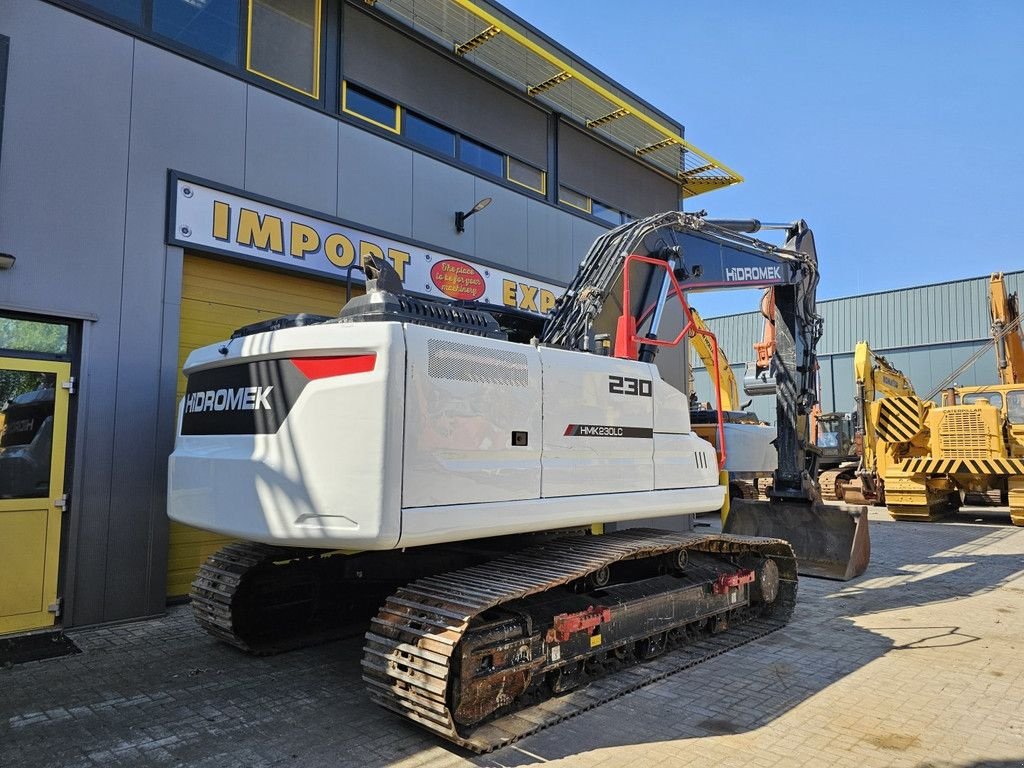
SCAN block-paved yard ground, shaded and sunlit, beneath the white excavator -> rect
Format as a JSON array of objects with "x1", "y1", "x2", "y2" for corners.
[{"x1": 0, "y1": 512, "x2": 1024, "y2": 768}]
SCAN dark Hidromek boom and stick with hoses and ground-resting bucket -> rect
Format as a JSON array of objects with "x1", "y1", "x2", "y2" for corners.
[{"x1": 542, "y1": 212, "x2": 869, "y2": 579}]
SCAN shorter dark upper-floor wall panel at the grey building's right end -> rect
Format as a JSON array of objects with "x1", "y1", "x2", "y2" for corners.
[{"x1": 558, "y1": 123, "x2": 679, "y2": 216}]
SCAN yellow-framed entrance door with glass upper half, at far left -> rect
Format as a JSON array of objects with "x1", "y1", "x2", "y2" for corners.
[{"x1": 0, "y1": 357, "x2": 71, "y2": 634}]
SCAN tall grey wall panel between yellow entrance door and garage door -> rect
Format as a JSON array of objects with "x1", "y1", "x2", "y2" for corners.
[{"x1": 113, "y1": 42, "x2": 247, "y2": 621}]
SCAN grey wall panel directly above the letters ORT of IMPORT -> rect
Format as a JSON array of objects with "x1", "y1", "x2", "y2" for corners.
[{"x1": 338, "y1": 123, "x2": 413, "y2": 238}]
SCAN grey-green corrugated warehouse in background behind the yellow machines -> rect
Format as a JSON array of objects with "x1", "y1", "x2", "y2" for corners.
[{"x1": 693, "y1": 271, "x2": 1024, "y2": 422}]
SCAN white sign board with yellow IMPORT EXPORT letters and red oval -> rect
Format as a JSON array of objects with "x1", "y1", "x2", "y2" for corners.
[{"x1": 168, "y1": 174, "x2": 564, "y2": 314}]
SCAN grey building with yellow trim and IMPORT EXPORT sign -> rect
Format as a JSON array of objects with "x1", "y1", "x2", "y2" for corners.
[{"x1": 0, "y1": 0, "x2": 740, "y2": 635}]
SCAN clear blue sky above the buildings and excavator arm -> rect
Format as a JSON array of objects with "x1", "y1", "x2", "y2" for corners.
[{"x1": 502, "y1": 0, "x2": 1024, "y2": 315}]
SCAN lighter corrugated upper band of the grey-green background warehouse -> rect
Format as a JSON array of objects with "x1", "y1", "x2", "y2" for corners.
[{"x1": 706, "y1": 270, "x2": 1024, "y2": 362}]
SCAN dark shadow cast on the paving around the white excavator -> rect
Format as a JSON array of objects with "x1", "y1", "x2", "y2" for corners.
[{"x1": 0, "y1": 520, "x2": 1024, "y2": 768}]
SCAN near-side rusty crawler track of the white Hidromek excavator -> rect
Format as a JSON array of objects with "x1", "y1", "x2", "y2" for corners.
[{"x1": 362, "y1": 528, "x2": 797, "y2": 753}]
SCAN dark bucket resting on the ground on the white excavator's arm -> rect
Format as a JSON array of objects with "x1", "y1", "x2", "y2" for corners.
[{"x1": 722, "y1": 499, "x2": 871, "y2": 582}]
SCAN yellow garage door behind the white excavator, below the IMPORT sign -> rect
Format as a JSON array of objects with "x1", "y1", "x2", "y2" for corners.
[{"x1": 167, "y1": 253, "x2": 362, "y2": 597}]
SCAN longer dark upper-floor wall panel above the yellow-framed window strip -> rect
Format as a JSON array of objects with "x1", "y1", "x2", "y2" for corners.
[{"x1": 343, "y1": 6, "x2": 548, "y2": 168}]
